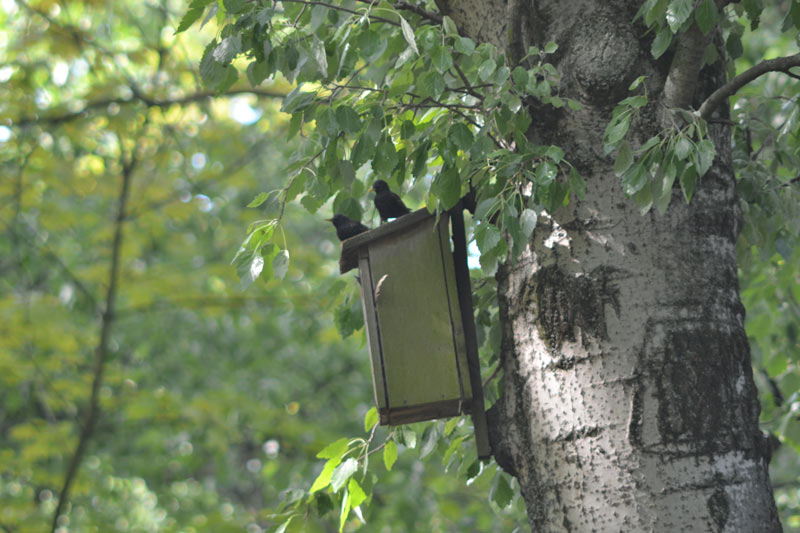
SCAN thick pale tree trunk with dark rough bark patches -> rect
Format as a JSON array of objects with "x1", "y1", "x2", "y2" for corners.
[{"x1": 440, "y1": 0, "x2": 781, "y2": 532}]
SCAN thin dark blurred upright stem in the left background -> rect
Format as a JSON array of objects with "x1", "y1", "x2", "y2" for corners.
[{"x1": 50, "y1": 136, "x2": 137, "y2": 533}]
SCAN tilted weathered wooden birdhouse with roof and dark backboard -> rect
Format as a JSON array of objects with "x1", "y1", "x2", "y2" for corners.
[{"x1": 340, "y1": 209, "x2": 490, "y2": 457}]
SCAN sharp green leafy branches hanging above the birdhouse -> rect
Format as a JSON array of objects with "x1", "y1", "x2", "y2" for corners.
[{"x1": 181, "y1": 1, "x2": 583, "y2": 283}]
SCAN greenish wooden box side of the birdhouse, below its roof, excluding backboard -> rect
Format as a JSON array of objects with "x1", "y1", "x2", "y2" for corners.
[{"x1": 359, "y1": 212, "x2": 472, "y2": 424}]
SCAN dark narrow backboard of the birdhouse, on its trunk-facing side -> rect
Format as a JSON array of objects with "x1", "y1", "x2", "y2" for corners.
[{"x1": 450, "y1": 202, "x2": 492, "y2": 459}]
